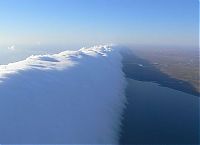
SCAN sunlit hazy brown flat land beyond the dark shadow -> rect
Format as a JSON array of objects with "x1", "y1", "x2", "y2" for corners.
[{"x1": 130, "y1": 48, "x2": 200, "y2": 92}]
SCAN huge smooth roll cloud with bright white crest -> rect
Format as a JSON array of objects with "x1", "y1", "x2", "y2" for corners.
[{"x1": 0, "y1": 46, "x2": 126, "y2": 144}]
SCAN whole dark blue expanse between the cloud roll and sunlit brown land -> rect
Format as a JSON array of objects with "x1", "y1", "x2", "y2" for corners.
[{"x1": 120, "y1": 49, "x2": 200, "y2": 144}]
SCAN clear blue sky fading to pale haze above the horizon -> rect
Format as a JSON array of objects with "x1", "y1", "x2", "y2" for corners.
[{"x1": 0, "y1": 0, "x2": 199, "y2": 48}]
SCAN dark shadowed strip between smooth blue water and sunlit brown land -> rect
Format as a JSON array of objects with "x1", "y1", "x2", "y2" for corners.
[{"x1": 122, "y1": 49, "x2": 199, "y2": 96}]
